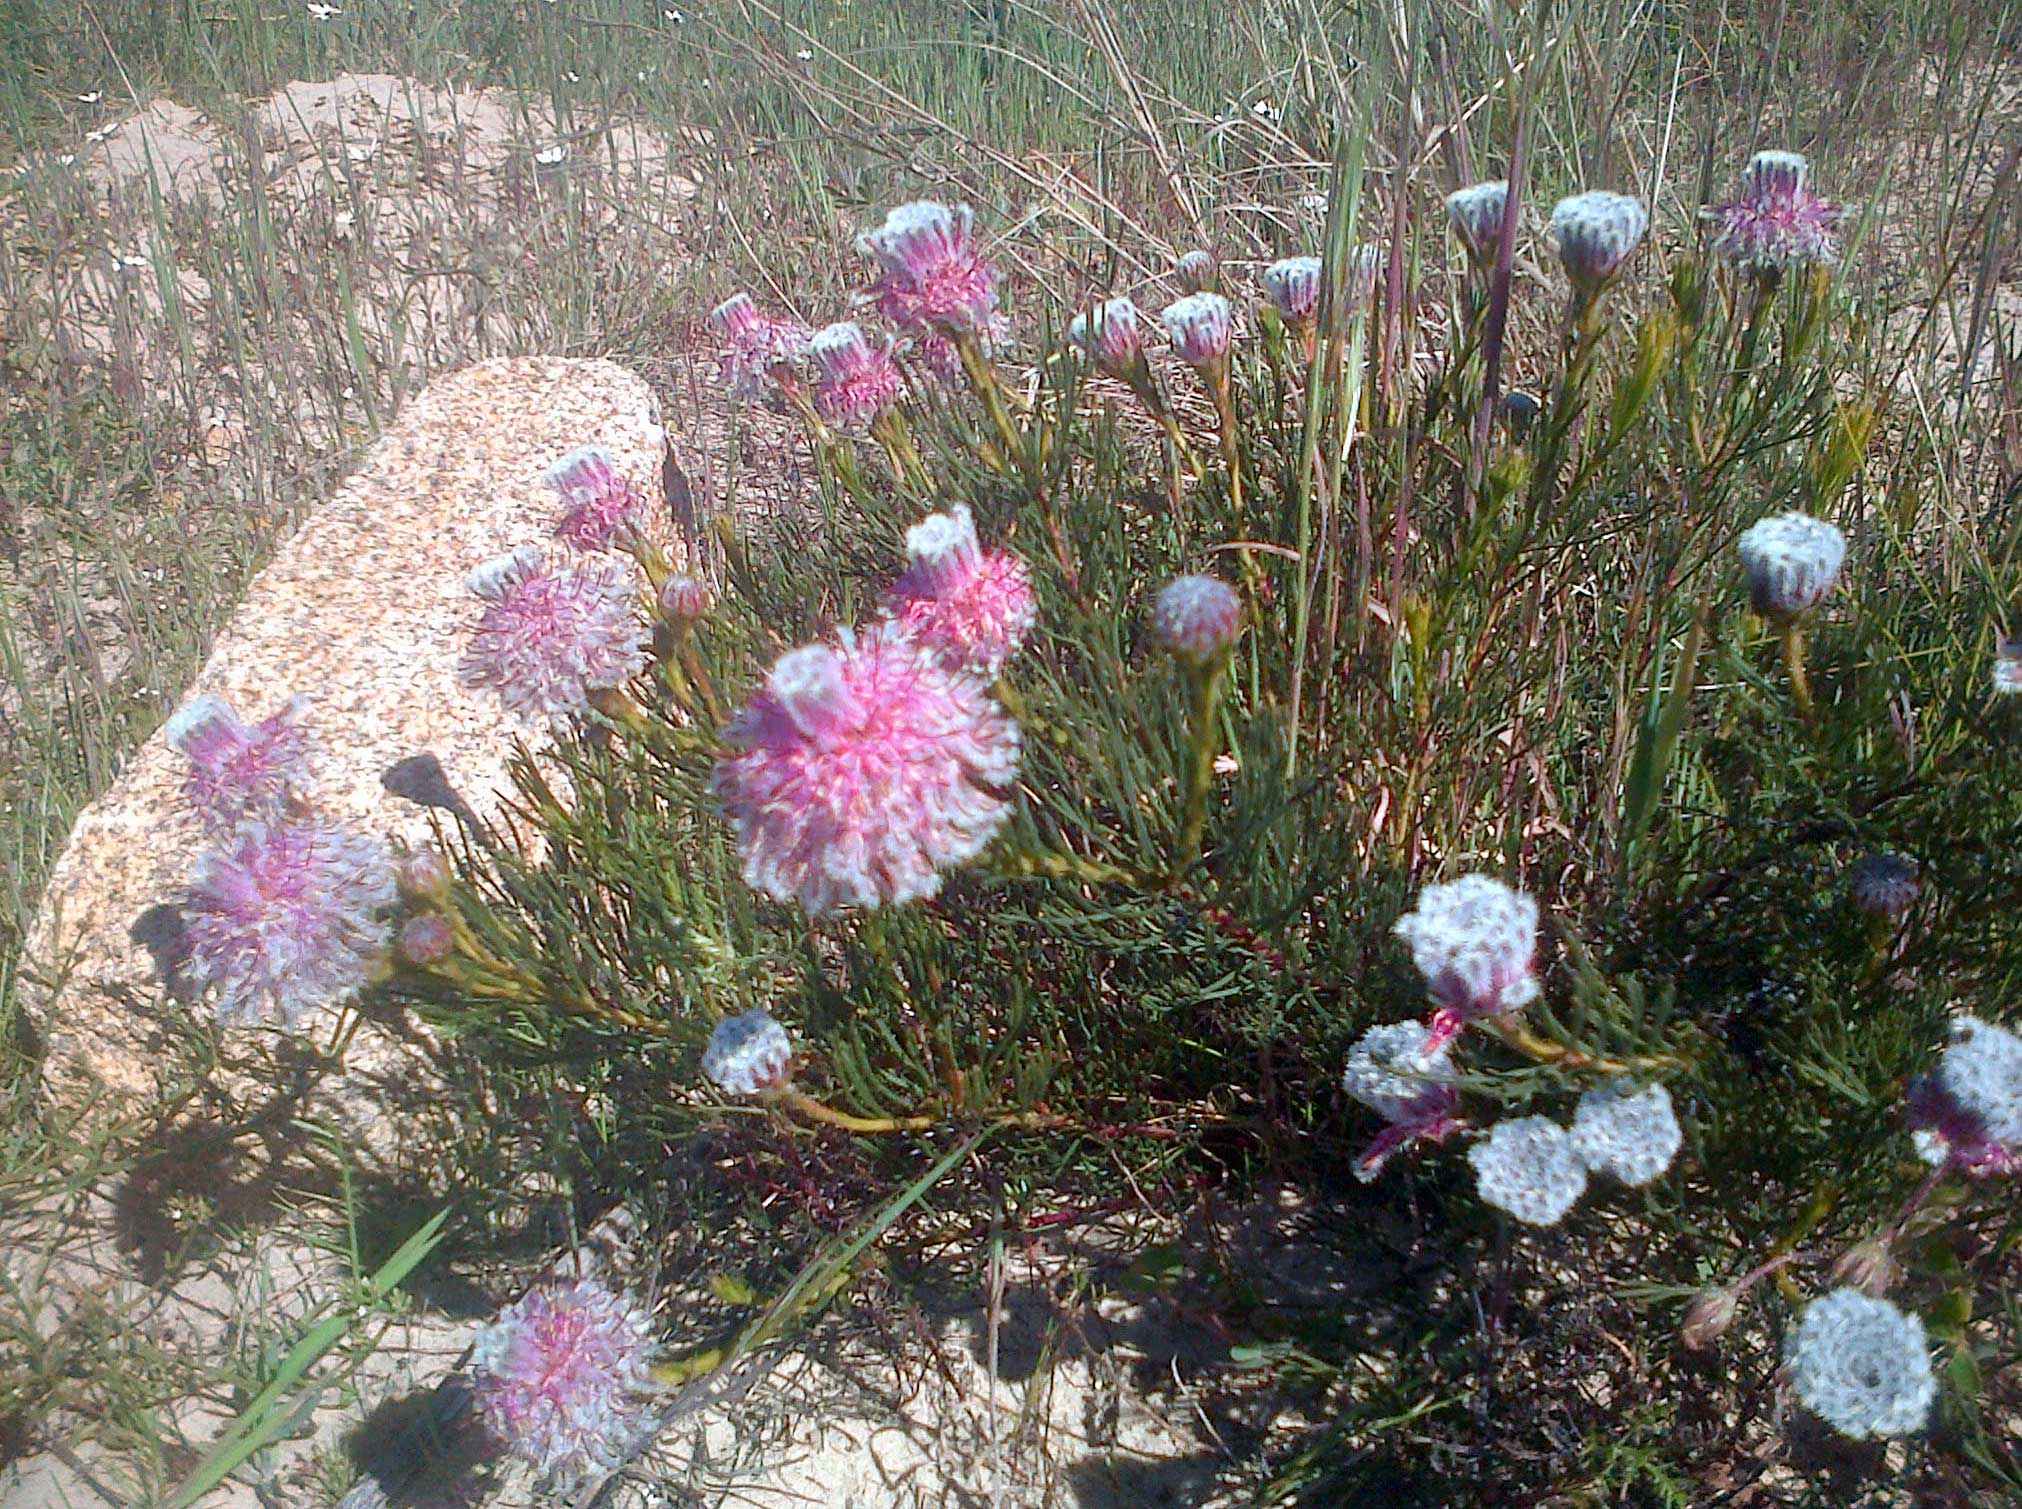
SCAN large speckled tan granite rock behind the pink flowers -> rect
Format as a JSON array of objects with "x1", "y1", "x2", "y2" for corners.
[{"x1": 24, "y1": 358, "x2": 667, "y2": 1100}]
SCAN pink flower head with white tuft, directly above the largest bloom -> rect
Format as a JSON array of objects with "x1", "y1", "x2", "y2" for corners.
[{"x1": 886, "y1": 504, "x2": 1037, "y2": 678}]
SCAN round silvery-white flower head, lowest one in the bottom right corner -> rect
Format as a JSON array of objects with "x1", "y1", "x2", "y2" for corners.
[{"x1": 1785, "y1": 1289, "x2": 1937, "y2": 1440}]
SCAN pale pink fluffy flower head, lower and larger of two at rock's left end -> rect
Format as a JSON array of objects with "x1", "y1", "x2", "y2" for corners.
[{"x1": 174, "y1": 821, "x2": 396, "y2": 1028}]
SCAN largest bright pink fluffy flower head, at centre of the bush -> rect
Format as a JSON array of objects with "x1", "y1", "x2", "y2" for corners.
[{"x1": 714, "y1": 623, "x2": 1019, "y2": 916}]
